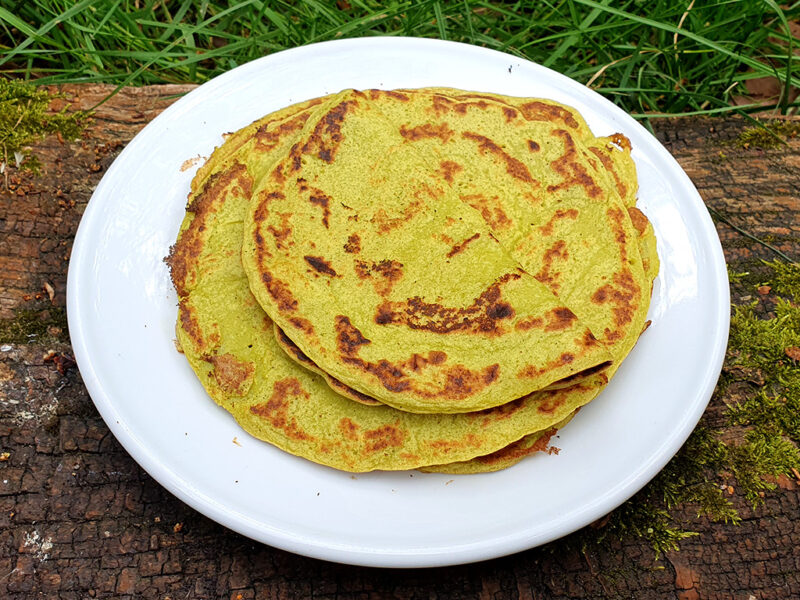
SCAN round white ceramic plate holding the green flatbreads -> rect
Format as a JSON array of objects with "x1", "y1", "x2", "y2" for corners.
[{"x1": 68, "y1": 38, "x2": 729, "y2": 567}]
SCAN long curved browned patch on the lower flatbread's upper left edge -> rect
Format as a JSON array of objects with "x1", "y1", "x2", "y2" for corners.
[{"x1": 165, "y1": 163, "x2": 253, "y2": 298}]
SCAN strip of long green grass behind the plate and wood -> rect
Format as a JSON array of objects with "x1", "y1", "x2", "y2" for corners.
[{"x1": 0, "y1": 0, "x2": 800, "y2": 116}]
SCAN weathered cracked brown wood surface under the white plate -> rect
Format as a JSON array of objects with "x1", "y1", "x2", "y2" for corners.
[{"x1": 0, "y1": 86, "x2": 800, "y2": 600}]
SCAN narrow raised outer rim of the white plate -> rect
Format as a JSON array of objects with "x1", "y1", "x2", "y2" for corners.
[{"x1": 67, "y1": 36, "x2": 730, "y2": 568}]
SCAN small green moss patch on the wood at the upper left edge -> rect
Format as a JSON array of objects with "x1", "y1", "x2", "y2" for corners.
[{"x1": 0, "y1": 78, "x2": 88, "y2": 174}]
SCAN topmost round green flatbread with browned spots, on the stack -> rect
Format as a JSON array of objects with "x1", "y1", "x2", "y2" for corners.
[{"x1": 243, "y1": 91, "x2": 643, "y2": 412}]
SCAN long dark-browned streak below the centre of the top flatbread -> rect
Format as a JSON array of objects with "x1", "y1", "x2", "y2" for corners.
[{"x1": 375, "y1": 273, "x2": 520, "y2": 335}]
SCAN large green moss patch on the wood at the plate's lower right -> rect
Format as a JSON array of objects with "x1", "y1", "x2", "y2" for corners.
[{"x1": 580, "y1": 261, "x2": 800, "y2": 557}]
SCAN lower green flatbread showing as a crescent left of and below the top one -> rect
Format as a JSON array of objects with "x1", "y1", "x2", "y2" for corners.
[{"x1": 168, "y1": 99, "x2": 605, "y2": 472}]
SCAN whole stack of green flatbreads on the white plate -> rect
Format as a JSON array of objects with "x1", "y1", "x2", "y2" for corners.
[{"x1": 167, "y1": 88, "x2": 658, "y2": 473}]
